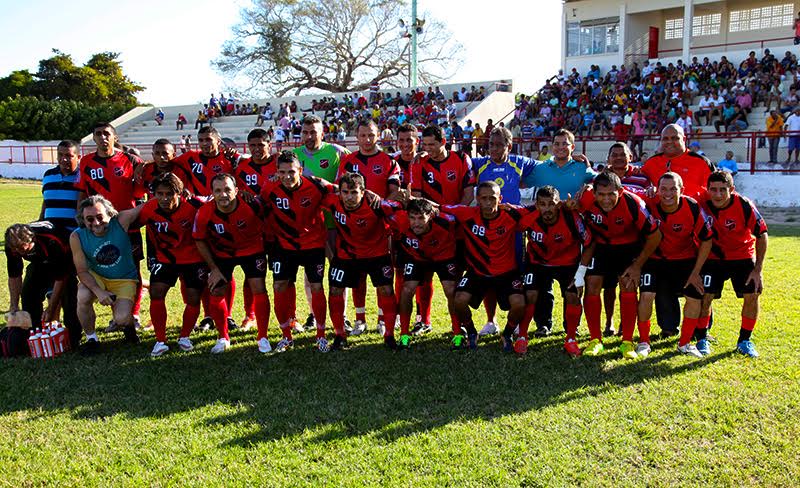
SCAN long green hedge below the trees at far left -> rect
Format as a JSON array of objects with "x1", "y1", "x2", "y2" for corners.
[{"x1": 0, "y1": 96, "x2": 133, "y2": 141}]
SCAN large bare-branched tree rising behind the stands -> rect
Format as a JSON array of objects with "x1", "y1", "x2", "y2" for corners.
[{"x1": 214, "y1": 0, "x2": 461, "y2": 96}]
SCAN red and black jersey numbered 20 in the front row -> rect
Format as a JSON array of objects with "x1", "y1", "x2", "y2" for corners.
[{"x1": 261, "y1": 176, "x2": 334, "y2": 251}]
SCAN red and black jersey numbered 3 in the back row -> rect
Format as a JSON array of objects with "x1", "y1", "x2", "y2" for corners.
[{"x1": 409, "y1": 151, "x2": 475, "y2": 205}]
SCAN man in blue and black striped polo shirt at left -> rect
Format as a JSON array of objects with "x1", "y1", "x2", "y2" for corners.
[{"x1": 39, "y1": 140, "x2": 80, "y2": 237}]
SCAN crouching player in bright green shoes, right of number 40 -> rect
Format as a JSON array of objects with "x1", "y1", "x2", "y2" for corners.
[{"x1": 389, "y1": 198, "x2": 461, "y2": 347}]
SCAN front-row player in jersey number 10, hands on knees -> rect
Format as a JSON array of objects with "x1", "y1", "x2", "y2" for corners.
[{"x1": 192, "y1": 173, "x2": 272, "y2": 354}]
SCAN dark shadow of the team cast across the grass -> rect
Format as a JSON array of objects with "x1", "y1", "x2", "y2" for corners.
[{"x1": 0, "y1": 326, "x2": 730, "y2": 446}]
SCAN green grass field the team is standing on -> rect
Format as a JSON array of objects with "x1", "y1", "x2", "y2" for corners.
[{"x1": 0, "y1": 182, "x2": 800, "y2": 487}]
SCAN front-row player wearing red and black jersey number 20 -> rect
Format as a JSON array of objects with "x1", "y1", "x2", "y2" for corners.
[{"x1": 261, "y1": 150, "x2": 336, "y2": 352}]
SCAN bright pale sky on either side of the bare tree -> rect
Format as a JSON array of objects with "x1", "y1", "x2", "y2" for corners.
[{"x1": 0, "y1": 0, "x2": 561, "y2": 105}]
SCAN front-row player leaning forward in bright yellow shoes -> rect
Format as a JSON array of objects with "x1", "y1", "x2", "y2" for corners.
[{"x1": 580, "y1": 172, "x2": 661, "y2": 359}]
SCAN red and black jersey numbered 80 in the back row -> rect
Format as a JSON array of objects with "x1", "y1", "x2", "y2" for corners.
[{"x1": 77, "y1": 151, "x2": 145, "y2": 212}]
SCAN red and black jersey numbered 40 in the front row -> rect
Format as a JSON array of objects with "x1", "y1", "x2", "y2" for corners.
[{"x1": 322, "y1": 193, "x2": 400, "y2": 259}]
